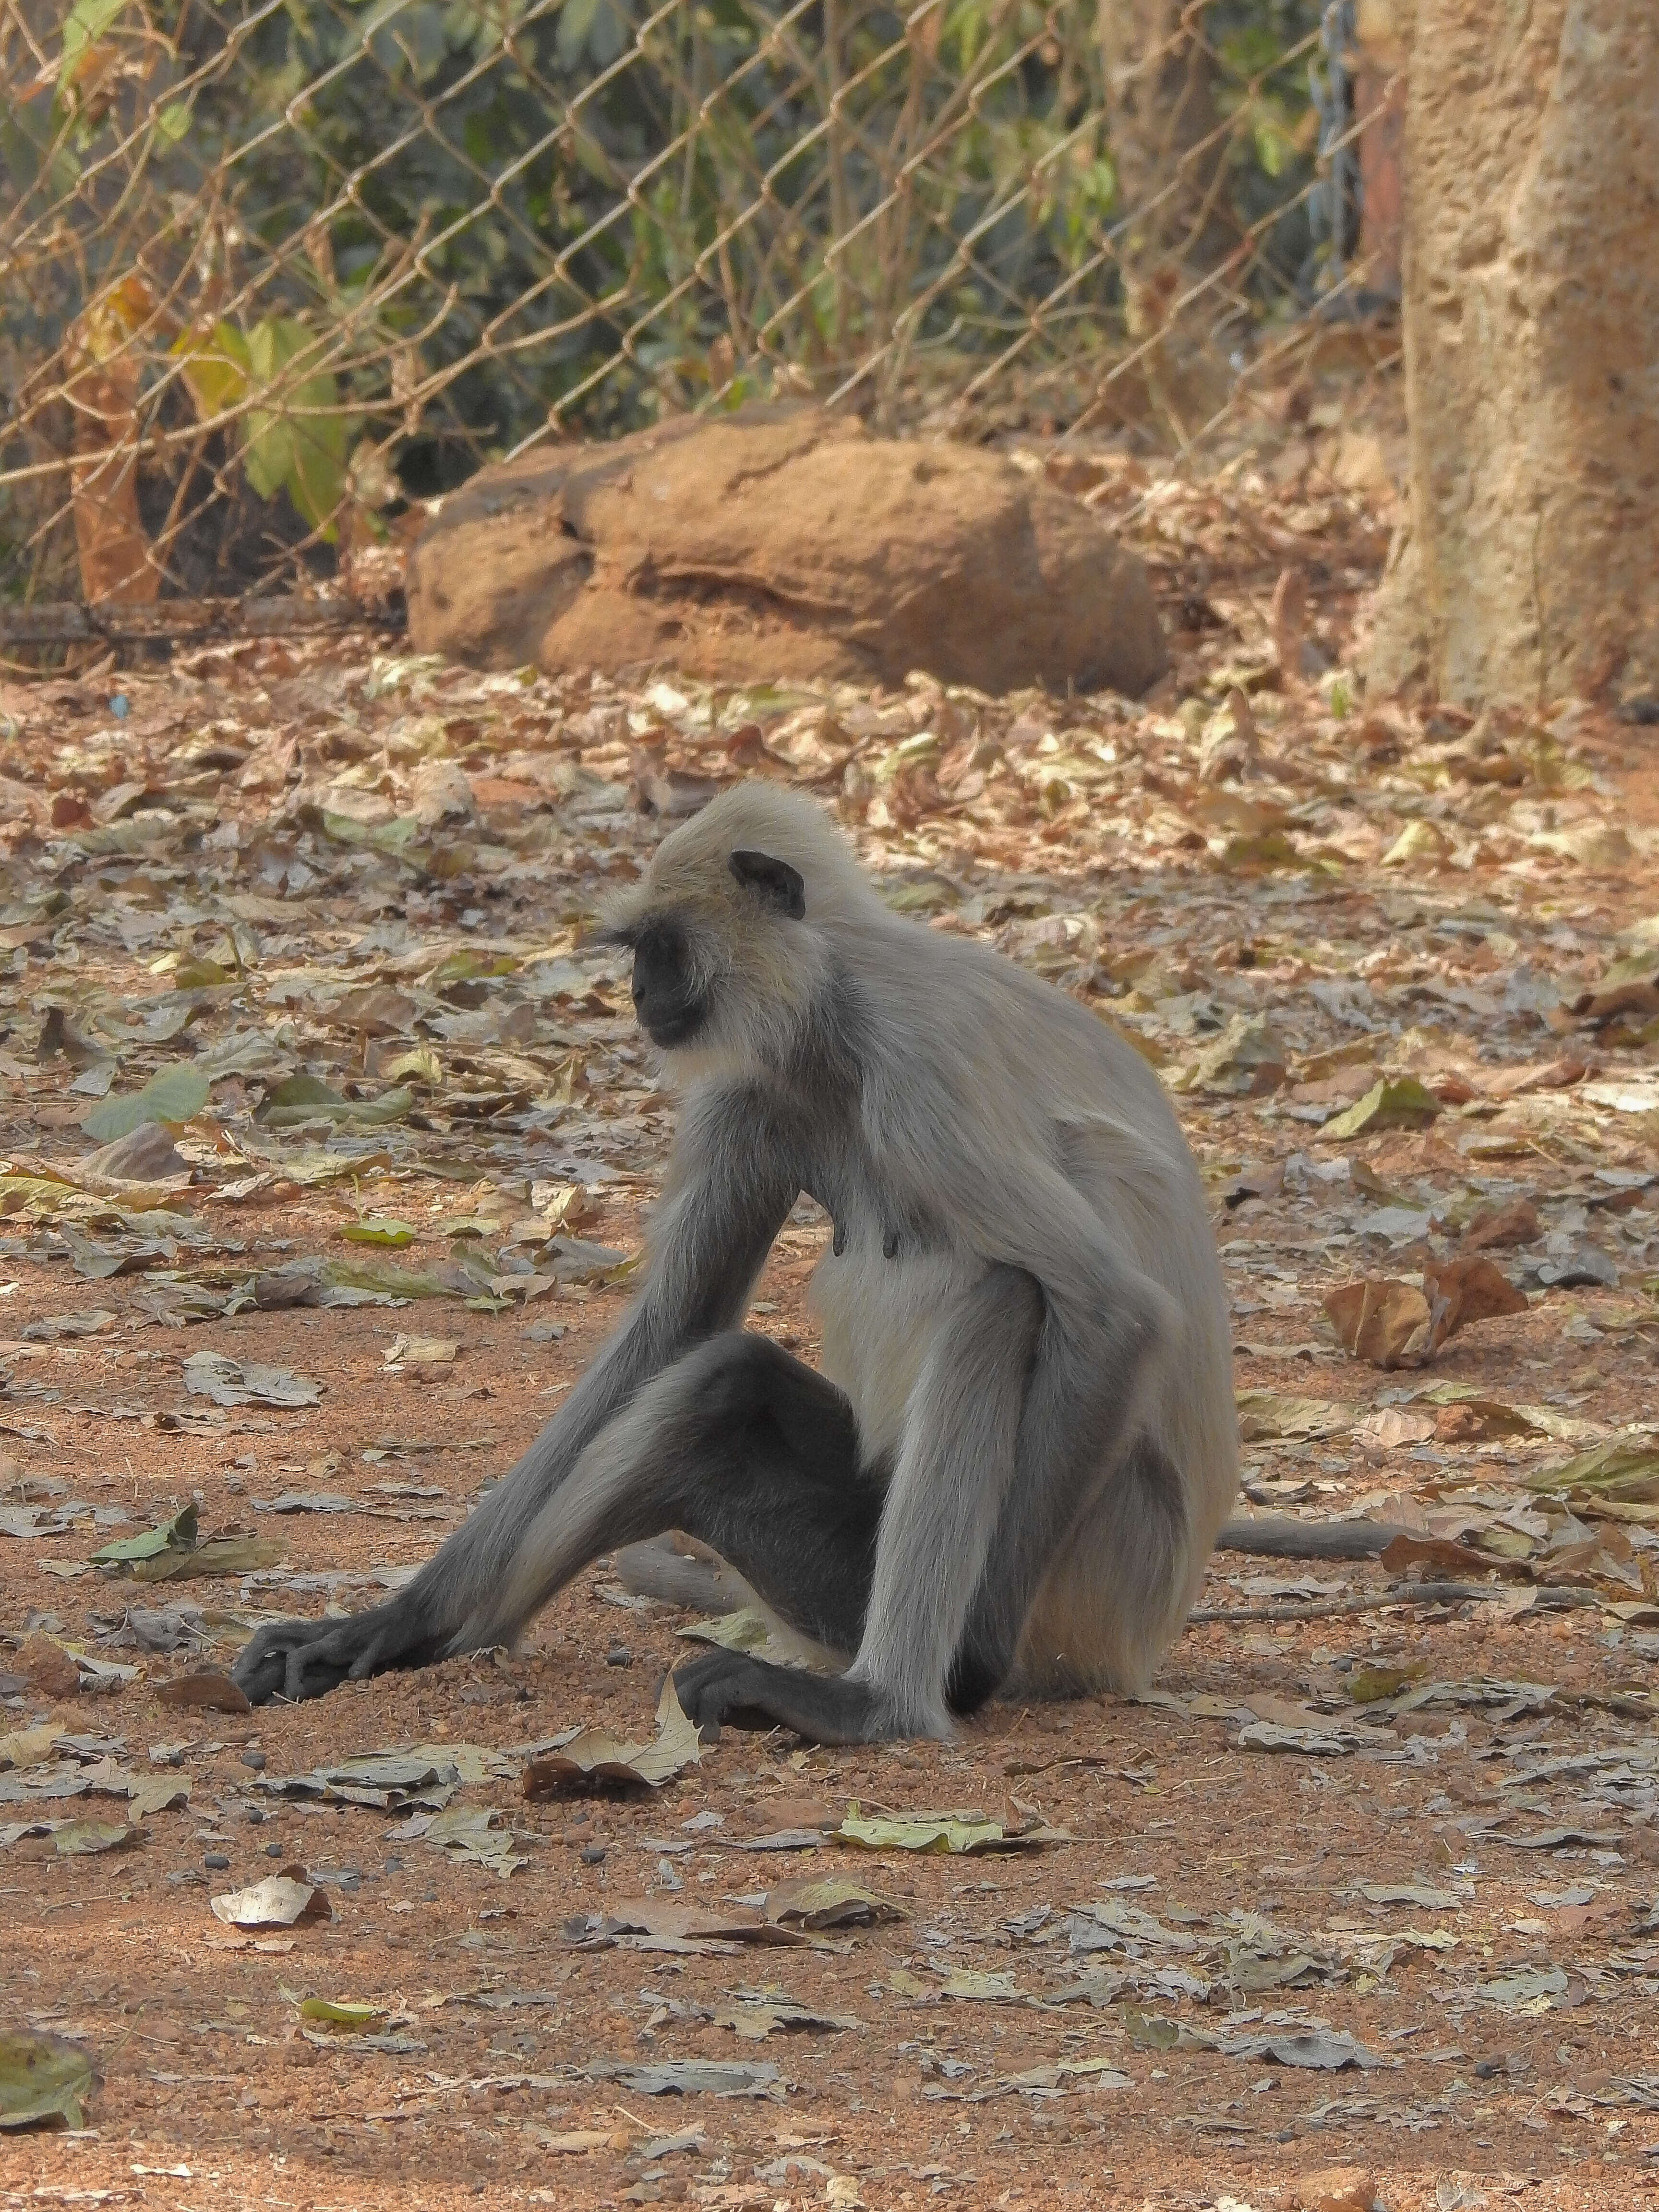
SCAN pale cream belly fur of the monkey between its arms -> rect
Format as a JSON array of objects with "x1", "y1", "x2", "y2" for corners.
[{"x1": 807, "y1": 1230, "x2": 985, "y2": 1460}]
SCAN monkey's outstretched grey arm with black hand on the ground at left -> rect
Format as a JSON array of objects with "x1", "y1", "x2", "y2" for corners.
[{"x1": 232, "y1": 1091, "x2": 801, "y2": 1706}]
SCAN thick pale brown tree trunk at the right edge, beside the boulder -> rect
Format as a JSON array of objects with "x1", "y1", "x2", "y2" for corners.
[{"x1": 1371, "y1": 0, "x2": 1659, "y2": 706}]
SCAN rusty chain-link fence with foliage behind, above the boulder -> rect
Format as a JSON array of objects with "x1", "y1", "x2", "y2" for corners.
[{"x1": 0, "y1": 0, "x2": 1394, "y2": 635}]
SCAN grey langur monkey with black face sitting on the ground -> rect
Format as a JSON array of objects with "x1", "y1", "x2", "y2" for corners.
[{"x1": 234, "y1": 783, "x2": 1238, "y2": 1743}]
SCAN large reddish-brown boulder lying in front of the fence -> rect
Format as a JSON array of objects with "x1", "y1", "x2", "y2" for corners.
[{"x1": 409, "y1": 407, "x2": 1166, "y2": 695}]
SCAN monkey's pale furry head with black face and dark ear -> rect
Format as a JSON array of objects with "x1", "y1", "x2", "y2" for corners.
[{"x1": 601, "y1": 783, "x2": 878, "y2": 1075}]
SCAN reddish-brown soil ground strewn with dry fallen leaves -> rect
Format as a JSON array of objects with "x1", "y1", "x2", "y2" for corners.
[{"x1": 0, "y1": 422, "x2": 1659, "y2": 2212}]
